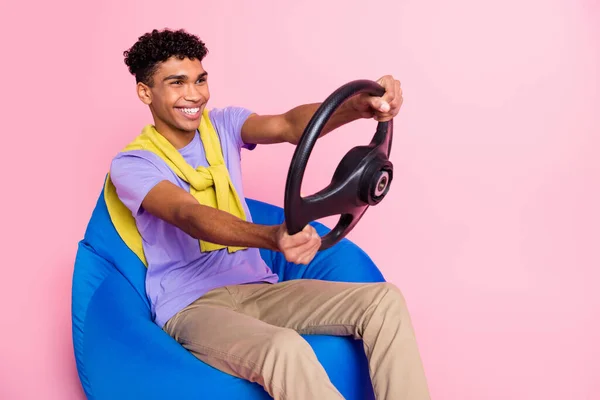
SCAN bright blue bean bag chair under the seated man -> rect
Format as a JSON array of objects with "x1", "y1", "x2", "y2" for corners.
[{"x1": 72, "y1": 188, "x2": 384, "y2": 400}]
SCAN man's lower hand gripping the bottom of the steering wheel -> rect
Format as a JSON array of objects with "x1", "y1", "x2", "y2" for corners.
[{"x1": 277, "y1": 222, "x2": 321, "y2": 265}]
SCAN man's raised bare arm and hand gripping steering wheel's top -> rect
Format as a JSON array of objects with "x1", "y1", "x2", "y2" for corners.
[{"x1": 242, "y1": 76, "x2": 402, "y2": 144}]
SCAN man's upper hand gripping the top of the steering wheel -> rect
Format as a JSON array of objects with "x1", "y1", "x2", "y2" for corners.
[{"x1": 349, "y1": 75, "x2": 403, "y2": 122}]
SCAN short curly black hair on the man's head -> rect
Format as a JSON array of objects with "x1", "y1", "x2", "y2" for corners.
[{"x1": 123, "y1": 29, "x2": 208, "y2": 86}]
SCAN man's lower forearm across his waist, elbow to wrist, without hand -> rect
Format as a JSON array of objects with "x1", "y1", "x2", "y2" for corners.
[{"x1": 177, "y1": 204, "x2": 279, "y2": 250}]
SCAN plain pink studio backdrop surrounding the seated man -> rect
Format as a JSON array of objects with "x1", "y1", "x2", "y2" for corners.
[{"x1": 0, "y1": 0, "x2": 600, "y2": 400}]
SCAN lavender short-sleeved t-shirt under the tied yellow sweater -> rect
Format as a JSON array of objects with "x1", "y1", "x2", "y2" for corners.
[{"x1": 110, "y1": 107, "x2": 278, "y2": 327}]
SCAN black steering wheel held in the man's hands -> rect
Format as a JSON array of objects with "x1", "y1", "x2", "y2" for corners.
[{"x1": 284, "y1": 80, "x2": 394, "y2": 251}]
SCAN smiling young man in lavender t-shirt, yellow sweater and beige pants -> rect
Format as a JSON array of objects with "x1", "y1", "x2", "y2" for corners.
[{"x1": 110, "y1": 30, "x2": 429, "y2": 400}]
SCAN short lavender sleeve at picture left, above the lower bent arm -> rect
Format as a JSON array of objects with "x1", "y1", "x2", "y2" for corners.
[{"x1": 110, "y1": 150, "x2": 172, "y2": 216}]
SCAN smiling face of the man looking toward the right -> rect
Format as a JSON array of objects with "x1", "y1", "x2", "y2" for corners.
[{"x1": 138, "y1": 57, "x2": 210, "y2": 133}]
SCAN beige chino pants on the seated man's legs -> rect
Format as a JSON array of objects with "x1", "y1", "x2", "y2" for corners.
[{"x1": 164, "y1": 279, "x2": 430, "y2": 400}]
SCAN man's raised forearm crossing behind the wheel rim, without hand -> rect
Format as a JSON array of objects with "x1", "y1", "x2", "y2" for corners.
[{"x1": 284, "y1": 102, "x2": 360, "y2": 144}]
